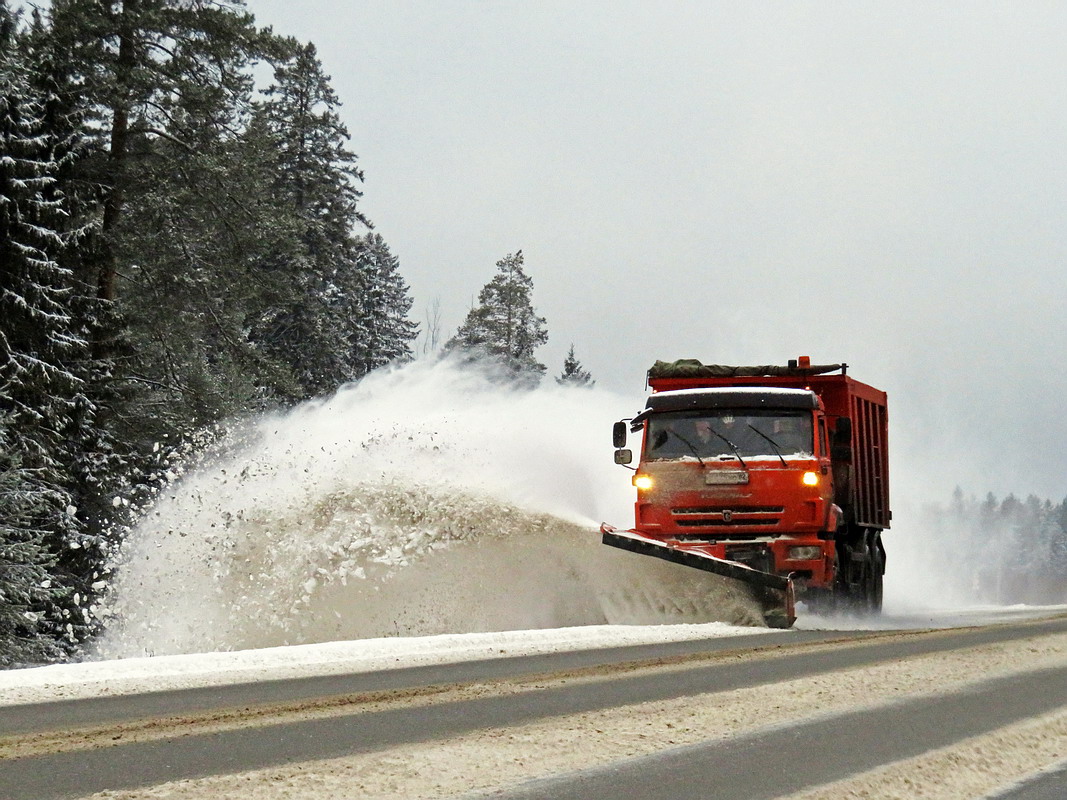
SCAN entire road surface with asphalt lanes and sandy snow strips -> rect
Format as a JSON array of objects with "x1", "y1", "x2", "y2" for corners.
[{"x1": 0, "y1": 615, "x2": 1067, "y2": 800}]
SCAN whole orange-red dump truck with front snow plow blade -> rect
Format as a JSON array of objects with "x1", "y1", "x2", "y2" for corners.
[{"x1": 601, "y1": 356, "x2": 892, "y2": 627}]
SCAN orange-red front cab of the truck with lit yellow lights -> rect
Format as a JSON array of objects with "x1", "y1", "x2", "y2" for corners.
[{"x1": 633, "y1": 388, "x2": 841, "y2": 589}]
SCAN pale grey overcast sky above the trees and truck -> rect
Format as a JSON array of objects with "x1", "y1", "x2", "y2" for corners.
[{"x1": 249, "y1": 0, "x2": 1067, "y2": 500}]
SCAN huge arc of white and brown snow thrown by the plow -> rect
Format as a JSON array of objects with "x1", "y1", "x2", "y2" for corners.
[{"x1": 95, "y1": 359, "x2": 762, "y2": 658}]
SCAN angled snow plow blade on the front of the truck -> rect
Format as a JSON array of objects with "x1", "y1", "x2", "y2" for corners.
[{"x1": 601, "y1": 524, "x2": 797, "y2": 628}]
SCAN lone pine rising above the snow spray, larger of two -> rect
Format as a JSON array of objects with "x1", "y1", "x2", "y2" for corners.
[{"x1": 445, "y1": 251, "x2": 548, "y2": 385}]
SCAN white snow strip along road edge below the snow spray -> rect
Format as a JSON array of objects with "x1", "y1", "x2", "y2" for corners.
[{"x1": 0, "y1": 622, "x2": 770, "y2": 705}]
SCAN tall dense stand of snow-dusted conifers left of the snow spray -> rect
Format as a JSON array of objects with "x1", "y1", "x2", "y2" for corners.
[{"x1": 0, "y1": 0, "x2": 417, "y2": 666}]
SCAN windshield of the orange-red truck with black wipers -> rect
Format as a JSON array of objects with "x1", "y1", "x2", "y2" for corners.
[{"x1": 644, "y1": 409, "x2": 814, "y2": 460}]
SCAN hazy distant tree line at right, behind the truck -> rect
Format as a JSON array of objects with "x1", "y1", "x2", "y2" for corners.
[{"x1": 924, "y1": 489, "x2": 1067, "y2": 604}]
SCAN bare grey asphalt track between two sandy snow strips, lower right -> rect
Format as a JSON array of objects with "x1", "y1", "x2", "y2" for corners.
[{"x1": 504, "y1": 667, "x2": 1067, "y2": 800}]
